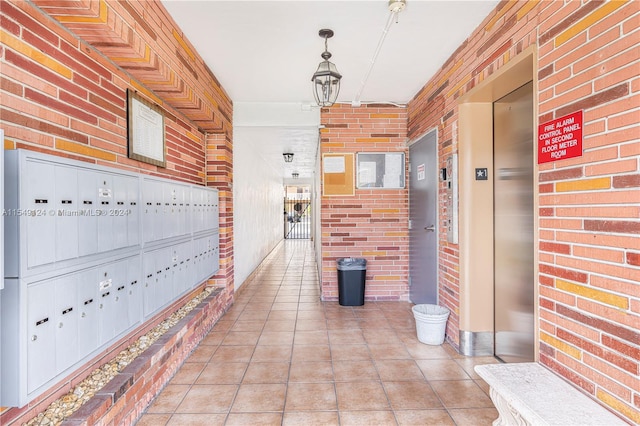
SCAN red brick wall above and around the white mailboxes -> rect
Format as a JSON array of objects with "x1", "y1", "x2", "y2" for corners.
[{"x1": 0, "y1": 1, "x2": 234, "y2": 424}]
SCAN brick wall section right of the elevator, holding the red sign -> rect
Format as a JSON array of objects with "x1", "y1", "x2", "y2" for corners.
[{"x1": 538, "y1": 2, "x2": 640, "y2": 423}]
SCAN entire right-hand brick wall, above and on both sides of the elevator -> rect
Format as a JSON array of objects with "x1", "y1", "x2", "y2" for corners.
[{"x1": 408, "y1": 1, "x2": 640, "y2": 423}]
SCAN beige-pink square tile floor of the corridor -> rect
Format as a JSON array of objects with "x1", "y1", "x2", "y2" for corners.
[{"x1": 138, "y1": 240, "x2": 498, "y2": 426}]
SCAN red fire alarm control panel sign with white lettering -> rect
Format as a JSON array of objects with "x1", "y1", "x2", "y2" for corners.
[{"x1": 538, "y1": 110, "x2": 583, "y2": 164}]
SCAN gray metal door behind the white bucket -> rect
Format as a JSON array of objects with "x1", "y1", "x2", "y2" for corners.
[{"x1": 409, "y1": 130, "x2": 438, "y2": 304}]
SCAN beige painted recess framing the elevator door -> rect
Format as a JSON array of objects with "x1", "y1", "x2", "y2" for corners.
[{"x1": 458, "y1": 46, "x2": 538, "y2": 338}]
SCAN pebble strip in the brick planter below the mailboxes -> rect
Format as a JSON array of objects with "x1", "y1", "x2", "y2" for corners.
[{"x1": 21, "y1": 287, "x2": 219, "y2": 426}]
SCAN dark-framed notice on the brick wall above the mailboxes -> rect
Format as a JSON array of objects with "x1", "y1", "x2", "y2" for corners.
[{"x1": 127, "y1": 89, "x2": 167, "y2": 167}]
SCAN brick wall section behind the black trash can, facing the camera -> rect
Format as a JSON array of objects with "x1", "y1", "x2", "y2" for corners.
[{"x1": 320, "y1": 105, "x2": 409, "y2": 300}]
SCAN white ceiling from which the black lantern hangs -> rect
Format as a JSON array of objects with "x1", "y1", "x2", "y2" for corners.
[{"x1": 163, "y1": 0, "x2": 498, "y2": 178}]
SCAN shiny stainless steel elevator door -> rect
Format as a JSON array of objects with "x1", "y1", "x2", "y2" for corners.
[{"x1": 493, "y1": 83, "x2": 535, "y2": 362}]
